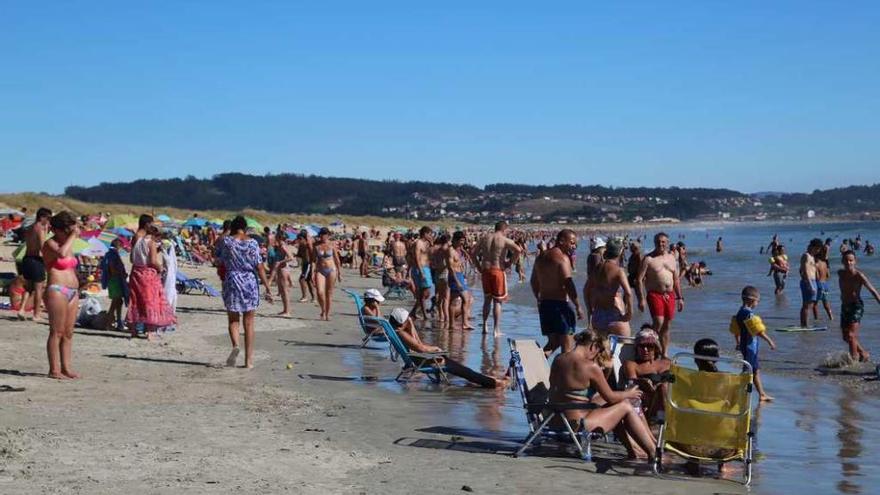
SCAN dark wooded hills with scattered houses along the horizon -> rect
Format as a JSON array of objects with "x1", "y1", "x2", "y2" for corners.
[{"x1": 65, "y1": 173, "x2": 880, "y2": 224}]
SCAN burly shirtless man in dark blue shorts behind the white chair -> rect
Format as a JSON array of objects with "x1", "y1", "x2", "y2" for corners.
[{"x1": 531, "y1": 229, "x2": 584, "y2": 356}]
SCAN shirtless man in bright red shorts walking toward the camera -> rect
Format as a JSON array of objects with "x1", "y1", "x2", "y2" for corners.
[{"x1": 638, "y1": 232, "x2": 684, "y2": 357}]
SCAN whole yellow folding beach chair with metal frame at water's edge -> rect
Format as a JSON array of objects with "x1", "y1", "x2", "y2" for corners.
[{"x1": 654, "y1": 352, "x2": 755, "y2": 486}]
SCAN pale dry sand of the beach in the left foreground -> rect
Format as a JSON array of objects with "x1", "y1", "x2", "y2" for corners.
[{"x1": 0, "y1": 246, "x2": 724, "y2": 494}]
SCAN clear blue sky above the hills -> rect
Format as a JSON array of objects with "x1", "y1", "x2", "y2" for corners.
[{"x1": 0, "y1": 1, "x2": 880, "y2": 193}]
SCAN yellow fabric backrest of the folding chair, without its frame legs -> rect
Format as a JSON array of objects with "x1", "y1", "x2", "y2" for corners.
[{"x1": 665, "y1": 364, "x2": 752, "y2": 452}]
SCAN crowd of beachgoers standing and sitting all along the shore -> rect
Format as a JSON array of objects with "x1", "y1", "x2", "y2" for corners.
[{"x1": 6, "y1": 208, "x2": 880, "y2": 480}]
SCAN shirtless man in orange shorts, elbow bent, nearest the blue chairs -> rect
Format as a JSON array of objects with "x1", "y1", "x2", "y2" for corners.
[{"x1": 474, "y1": 220, "x2": 520, "y2": 337}]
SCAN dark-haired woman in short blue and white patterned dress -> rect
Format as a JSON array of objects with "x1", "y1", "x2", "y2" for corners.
[{"x1": 217, "y1": 216, "x2": 272, "y2": 368}]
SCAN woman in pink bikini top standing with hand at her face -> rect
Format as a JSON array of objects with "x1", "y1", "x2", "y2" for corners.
[{"x1": 41, "y1": 211, "x2": 79, "y2": 380}]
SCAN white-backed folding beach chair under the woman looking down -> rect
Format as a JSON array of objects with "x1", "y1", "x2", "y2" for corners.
[{"x1": 507, "y1": 339, "x2": 598, "y2": 461}]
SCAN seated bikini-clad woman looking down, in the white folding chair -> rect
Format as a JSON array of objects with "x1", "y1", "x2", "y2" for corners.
[{"x1": 550, "y1": 330, "x2": 656, "y2": 459}]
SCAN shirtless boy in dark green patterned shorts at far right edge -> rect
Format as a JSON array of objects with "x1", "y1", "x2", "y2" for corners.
[{"x1": 837, "y1": 251, "x2": 880, "y2": 361}]
